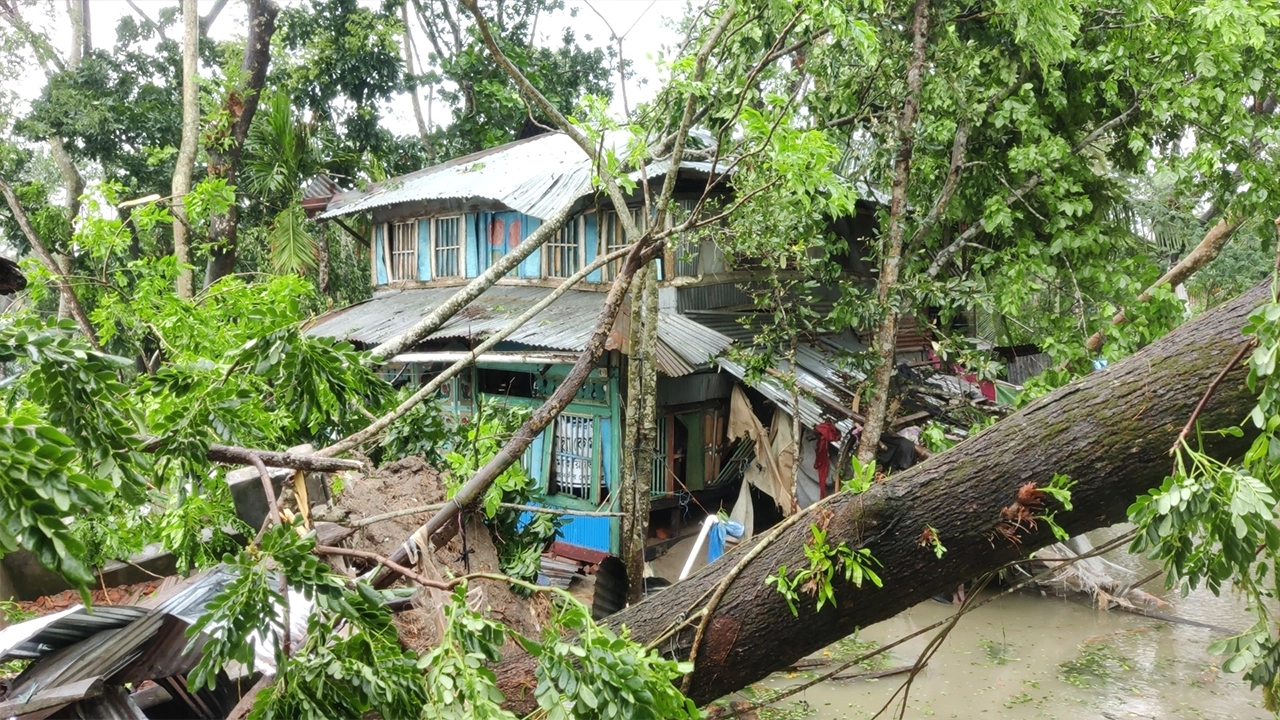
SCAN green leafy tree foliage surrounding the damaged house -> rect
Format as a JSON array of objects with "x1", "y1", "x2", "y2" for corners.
[{"x1": 0, "y1": 0, "x2": 1280, "y2": 717}]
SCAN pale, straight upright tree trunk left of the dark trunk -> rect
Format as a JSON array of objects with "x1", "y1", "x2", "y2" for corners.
[{"x1": 172, "y1": 0, "x2": 200, "y2": 300}]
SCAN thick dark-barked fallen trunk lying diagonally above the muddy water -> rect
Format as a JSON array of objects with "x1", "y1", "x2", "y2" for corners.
[{"x1": 498, "y1": 275, "x2": 1270, "y2": 708}]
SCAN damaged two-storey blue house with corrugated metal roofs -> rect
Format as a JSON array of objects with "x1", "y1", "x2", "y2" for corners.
[{"x1": 308, "y1": 133, "x2": 983, "y2": 564}]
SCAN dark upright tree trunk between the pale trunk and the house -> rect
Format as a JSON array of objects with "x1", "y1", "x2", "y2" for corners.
[{"x1": 205, "y1": 0, "x2": 280, "y2": 287}]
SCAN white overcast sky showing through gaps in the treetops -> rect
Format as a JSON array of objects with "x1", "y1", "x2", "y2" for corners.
[{"x1": 7, "y1": 0, "x2": 696, "y2": 135}]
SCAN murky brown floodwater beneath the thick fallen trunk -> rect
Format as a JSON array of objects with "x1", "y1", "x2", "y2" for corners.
[{"x1": 746, "y1": 532, "x2": 1271, "y2": 720}]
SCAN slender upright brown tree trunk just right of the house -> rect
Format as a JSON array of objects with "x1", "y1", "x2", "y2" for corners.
[{"x1": 860, "y1": 0, "x2": 929, "y2": 462}]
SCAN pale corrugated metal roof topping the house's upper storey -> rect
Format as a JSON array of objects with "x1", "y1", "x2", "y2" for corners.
[{"x1": 320, "y1": 132, "x2": 727, "y2": 219}]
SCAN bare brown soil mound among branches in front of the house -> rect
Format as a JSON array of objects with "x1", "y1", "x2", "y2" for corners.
[{"x1": 326, "y1": 457, "x2": 550, "y2": 653}]
